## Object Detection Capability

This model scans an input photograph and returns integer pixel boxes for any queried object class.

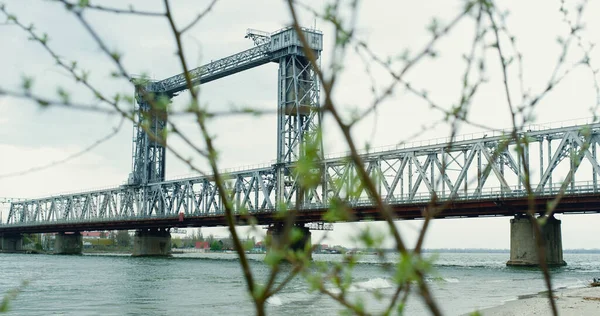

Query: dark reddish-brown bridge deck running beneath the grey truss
[0,193,600,234]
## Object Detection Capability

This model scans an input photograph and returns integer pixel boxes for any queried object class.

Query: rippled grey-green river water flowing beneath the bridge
[0,253,600,316]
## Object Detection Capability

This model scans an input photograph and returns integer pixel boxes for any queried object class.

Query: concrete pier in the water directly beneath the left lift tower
[132,228,171,257]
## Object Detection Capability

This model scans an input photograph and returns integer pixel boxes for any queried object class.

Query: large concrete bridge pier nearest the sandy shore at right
[506,216,567,267]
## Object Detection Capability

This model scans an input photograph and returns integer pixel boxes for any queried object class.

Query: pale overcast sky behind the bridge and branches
[0,0,600,248]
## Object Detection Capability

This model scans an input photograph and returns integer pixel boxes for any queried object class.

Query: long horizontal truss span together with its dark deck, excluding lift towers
[0,124,600,231]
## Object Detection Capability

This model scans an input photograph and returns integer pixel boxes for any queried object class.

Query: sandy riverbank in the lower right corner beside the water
[480,287,600,316]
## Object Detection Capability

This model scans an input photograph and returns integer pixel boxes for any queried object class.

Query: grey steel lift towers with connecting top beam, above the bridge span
[128,27,323,213]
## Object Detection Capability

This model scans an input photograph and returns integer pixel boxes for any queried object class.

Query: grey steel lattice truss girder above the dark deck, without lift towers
[7,124,600,225]
